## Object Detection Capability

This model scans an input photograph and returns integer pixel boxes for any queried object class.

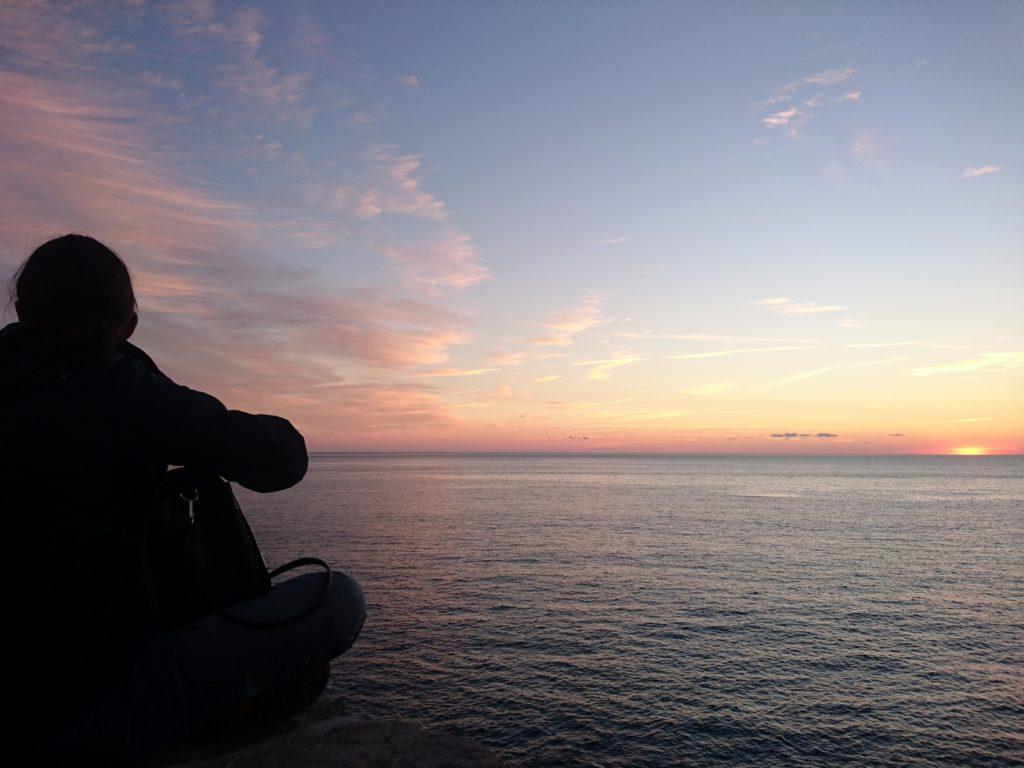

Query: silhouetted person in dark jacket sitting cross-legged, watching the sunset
[0,234,365,765]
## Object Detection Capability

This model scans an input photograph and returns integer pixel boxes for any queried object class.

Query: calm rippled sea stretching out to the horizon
[239,455,1024,766]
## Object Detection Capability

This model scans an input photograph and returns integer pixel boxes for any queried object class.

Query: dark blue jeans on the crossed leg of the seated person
[60,571,366,762]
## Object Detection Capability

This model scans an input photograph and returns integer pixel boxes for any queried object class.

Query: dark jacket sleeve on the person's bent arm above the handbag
[103,353,308,493]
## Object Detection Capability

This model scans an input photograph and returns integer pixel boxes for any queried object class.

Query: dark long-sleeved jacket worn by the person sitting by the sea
[0,323,307,741]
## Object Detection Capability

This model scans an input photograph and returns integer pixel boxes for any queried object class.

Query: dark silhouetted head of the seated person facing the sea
[11,234,138,365]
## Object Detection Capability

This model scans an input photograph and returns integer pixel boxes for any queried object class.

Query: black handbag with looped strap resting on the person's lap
[142,467,331,630]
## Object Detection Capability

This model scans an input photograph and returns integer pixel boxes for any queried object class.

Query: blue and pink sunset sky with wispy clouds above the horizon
[0,0,1024,455]
